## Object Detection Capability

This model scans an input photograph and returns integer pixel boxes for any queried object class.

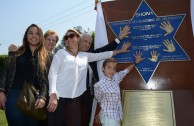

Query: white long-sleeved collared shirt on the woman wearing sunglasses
[48,49,113,98]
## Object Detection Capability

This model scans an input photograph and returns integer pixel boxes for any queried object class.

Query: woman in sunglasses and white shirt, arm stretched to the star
[48,29,129,126]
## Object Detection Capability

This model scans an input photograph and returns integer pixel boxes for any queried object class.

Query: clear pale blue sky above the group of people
[0,0,112,55]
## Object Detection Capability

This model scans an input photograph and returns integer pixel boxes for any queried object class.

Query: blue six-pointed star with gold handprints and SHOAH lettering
[108,0,190,83]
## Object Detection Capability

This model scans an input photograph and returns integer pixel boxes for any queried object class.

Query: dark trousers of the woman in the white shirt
[48,96,81,126]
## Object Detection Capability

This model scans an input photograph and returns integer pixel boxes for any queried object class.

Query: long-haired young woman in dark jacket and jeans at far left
[0,24,50,126]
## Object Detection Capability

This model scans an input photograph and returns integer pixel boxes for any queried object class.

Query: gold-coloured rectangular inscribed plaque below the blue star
[122,90,176,126]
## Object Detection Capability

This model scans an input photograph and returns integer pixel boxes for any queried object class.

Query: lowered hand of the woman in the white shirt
[47,93,58,112]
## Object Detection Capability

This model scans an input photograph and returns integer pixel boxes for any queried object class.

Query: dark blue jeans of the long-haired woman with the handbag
[5,89,38,126]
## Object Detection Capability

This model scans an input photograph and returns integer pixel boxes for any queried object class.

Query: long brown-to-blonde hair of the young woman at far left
[16,24,49,74]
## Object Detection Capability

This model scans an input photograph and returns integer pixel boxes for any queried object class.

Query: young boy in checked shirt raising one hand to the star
[94,52,144,126]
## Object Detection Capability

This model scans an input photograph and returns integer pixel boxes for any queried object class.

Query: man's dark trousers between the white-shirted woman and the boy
[81,88,93,126]
